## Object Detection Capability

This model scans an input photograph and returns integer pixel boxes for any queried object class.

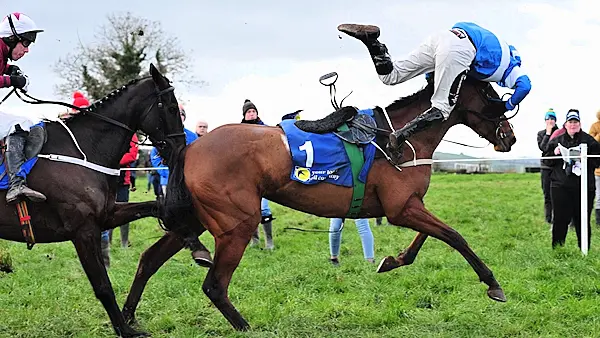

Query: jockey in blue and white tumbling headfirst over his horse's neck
[338,22,531,163]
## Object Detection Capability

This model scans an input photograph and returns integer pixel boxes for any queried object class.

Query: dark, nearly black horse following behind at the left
[0,65,185,337]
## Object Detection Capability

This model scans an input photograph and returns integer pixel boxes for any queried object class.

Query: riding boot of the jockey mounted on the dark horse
[6,131,46,204]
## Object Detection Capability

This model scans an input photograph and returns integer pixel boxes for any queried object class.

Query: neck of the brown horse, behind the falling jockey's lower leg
[388,101,456,159]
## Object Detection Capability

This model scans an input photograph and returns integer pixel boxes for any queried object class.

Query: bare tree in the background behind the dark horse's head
[54,12,204,99]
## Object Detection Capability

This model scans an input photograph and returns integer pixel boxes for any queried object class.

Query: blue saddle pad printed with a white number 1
[279,110,375,187]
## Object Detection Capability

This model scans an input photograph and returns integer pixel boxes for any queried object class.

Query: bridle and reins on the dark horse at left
[11,84,185,149]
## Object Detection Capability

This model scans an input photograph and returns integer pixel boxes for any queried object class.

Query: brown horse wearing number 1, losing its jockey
[123,76,516,330]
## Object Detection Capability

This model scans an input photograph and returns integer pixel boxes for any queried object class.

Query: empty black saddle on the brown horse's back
[295,107,377,145]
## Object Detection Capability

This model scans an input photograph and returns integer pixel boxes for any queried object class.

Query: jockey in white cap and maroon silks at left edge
[0,13,46,203]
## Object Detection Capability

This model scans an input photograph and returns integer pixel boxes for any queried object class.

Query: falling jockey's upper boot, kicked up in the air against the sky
[338,24,394,75]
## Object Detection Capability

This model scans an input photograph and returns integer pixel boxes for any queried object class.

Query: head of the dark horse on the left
[138,64,185,164]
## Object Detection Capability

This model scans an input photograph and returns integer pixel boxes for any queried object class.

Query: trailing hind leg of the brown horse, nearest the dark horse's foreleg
[123,232,185,324]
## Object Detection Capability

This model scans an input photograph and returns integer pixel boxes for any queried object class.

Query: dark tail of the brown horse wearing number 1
[163,147,193,230]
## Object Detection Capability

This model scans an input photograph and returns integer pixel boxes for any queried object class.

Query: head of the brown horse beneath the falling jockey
[454,78,517,152]
